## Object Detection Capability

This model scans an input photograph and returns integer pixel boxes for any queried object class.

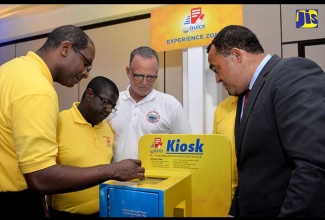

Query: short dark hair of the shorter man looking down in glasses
[82,76,119,99]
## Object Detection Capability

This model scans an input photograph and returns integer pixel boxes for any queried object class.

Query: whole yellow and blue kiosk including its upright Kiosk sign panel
[99,134,232,217]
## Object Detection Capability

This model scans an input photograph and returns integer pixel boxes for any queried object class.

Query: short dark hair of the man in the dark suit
[207,25,264,56]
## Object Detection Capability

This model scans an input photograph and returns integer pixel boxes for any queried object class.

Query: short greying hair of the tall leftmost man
[39,25,94,51]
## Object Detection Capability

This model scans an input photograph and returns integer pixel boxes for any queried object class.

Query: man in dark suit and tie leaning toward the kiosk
[207,25,325,217]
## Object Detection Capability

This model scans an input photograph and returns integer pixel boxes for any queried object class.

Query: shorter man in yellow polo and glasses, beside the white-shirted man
[50,76,119,219]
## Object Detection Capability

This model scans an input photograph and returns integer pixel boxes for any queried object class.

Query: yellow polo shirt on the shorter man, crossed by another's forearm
[52,102,114,214]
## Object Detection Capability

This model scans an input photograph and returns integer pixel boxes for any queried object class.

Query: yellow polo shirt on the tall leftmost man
[0,51,59,191]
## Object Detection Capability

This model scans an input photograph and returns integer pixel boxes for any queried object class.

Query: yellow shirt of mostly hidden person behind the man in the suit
[213,96,238,196]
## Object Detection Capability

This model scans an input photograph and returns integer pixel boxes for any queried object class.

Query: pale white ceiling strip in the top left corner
[0,4,165,43]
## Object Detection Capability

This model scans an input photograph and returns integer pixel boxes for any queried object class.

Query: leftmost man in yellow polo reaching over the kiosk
[0,25,144,219]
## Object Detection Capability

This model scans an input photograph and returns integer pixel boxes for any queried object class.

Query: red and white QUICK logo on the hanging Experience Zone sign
[183,7,205,33]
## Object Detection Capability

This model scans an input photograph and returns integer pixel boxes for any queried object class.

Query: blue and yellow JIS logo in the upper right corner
[296,9,318,28]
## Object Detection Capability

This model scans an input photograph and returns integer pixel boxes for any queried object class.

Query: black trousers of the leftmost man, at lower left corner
[0,189,46,219]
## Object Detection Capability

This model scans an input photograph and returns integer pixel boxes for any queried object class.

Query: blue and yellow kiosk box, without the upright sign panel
[100,171,192,217]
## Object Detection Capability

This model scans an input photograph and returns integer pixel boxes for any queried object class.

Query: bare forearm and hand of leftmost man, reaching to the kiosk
[24,159,145,194]
